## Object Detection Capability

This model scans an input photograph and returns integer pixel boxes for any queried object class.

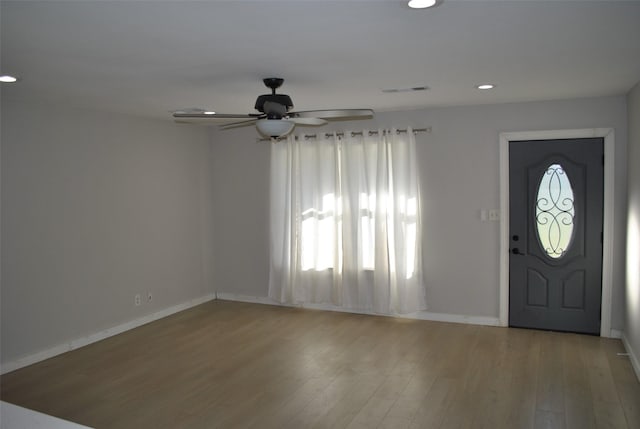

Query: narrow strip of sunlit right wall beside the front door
[624,82,640,368]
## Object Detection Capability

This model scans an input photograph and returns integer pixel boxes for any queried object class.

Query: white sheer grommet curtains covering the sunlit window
[269,125,426,314]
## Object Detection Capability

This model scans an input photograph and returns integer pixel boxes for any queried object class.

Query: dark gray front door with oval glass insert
[509,138,604,334]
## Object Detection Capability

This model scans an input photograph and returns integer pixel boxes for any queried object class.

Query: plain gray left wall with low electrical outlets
[1,100,213,363]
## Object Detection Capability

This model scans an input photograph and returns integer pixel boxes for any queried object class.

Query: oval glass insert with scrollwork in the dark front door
[536,164,575,259]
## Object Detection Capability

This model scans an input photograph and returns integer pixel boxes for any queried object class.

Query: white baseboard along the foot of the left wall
[0,294,216,374]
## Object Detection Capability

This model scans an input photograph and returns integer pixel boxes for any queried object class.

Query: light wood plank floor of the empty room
[0,301,640,429]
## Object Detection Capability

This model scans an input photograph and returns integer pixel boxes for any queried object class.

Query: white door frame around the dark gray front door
[500,128,615,337]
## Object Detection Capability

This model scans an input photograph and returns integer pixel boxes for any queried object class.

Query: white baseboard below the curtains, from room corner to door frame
[217,292,500,326]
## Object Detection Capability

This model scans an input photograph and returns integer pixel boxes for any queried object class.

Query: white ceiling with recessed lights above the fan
[0,0,640,120]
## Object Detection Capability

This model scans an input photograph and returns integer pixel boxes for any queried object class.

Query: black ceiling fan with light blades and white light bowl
[173,77,373,138]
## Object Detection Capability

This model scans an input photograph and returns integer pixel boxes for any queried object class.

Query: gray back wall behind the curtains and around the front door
[212,97,627,329]
